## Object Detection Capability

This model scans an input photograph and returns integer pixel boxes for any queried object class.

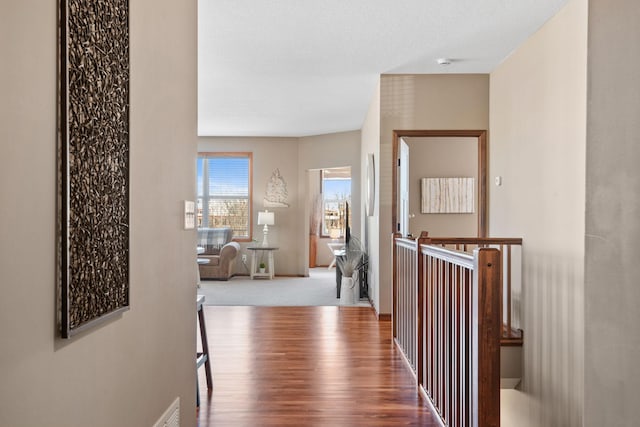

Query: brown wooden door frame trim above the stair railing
[391,130,488,237]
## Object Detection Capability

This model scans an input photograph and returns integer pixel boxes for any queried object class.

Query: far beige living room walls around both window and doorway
[197,131,360,275]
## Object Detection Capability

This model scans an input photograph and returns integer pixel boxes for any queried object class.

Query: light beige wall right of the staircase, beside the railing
[489,0,588,427]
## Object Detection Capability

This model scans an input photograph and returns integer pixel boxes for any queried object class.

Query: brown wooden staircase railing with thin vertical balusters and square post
[392,233,522,426]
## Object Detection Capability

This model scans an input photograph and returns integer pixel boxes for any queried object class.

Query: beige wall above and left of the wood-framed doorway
[376,74,489,313]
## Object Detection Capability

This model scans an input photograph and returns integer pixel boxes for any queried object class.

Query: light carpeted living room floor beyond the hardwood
[198,267,369,306]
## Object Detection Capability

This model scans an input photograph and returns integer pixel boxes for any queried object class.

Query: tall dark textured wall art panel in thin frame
[59,0,129,338]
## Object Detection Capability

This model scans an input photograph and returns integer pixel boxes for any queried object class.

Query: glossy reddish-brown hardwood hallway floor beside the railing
[198,306,440,427]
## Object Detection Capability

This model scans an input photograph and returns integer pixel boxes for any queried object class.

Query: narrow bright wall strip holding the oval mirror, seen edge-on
[360,80,380,313]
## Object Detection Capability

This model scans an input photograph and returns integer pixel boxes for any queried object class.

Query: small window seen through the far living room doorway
[320,167,351,237]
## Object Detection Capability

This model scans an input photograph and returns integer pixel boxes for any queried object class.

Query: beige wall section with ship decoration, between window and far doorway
[194,137,306,276]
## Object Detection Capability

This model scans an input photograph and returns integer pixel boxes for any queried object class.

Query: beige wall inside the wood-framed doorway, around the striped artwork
[404,137,478,237]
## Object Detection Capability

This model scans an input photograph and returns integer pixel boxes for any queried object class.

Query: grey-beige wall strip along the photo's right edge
[584,0,640,427]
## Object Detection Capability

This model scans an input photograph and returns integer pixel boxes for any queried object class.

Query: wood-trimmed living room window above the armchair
[196,153,252,240]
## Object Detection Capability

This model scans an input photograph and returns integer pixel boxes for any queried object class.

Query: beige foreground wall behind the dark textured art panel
[0,0,196,427]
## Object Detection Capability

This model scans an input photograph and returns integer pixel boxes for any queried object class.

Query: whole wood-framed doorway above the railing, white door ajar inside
[391,130,487,237]
